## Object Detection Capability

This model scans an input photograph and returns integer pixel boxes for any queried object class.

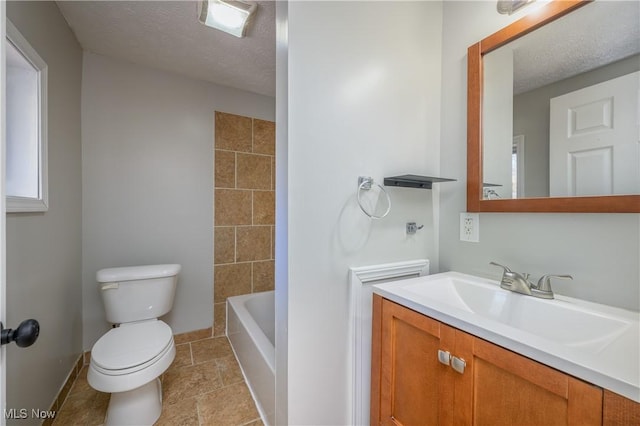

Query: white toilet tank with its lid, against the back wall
[96,264,181,324]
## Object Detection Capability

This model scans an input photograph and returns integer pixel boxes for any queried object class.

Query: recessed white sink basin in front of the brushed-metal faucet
[404,274,631,349]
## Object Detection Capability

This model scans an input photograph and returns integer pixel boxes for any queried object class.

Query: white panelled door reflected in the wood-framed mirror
[549,72,640,197]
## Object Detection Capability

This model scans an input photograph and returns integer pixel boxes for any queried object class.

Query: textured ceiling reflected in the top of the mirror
[508,0,640,93]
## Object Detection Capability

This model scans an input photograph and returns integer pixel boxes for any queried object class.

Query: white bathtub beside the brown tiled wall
[227,291,276,426]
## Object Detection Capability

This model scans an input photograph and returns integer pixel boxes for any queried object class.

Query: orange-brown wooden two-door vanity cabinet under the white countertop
[371,295,603,426]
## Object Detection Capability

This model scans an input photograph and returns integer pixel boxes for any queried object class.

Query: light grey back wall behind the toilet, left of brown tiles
[82,52,275,350]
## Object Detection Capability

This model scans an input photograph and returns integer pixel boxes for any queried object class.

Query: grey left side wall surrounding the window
[6,2,82,423]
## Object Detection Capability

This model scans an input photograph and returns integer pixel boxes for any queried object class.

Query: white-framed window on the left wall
[6,20,48,213]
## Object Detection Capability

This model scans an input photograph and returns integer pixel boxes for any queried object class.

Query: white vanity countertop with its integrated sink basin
[373,272,640,402]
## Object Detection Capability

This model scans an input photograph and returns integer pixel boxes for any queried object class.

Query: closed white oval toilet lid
[91,320,173,370]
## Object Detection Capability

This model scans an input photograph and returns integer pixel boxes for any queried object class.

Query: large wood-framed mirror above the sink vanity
[467,0,640,213]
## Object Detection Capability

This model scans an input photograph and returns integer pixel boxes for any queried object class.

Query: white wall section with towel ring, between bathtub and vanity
[276,2,442,425]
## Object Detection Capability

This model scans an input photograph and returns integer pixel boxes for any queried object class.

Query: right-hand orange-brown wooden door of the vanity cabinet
[454,330,602,426]
